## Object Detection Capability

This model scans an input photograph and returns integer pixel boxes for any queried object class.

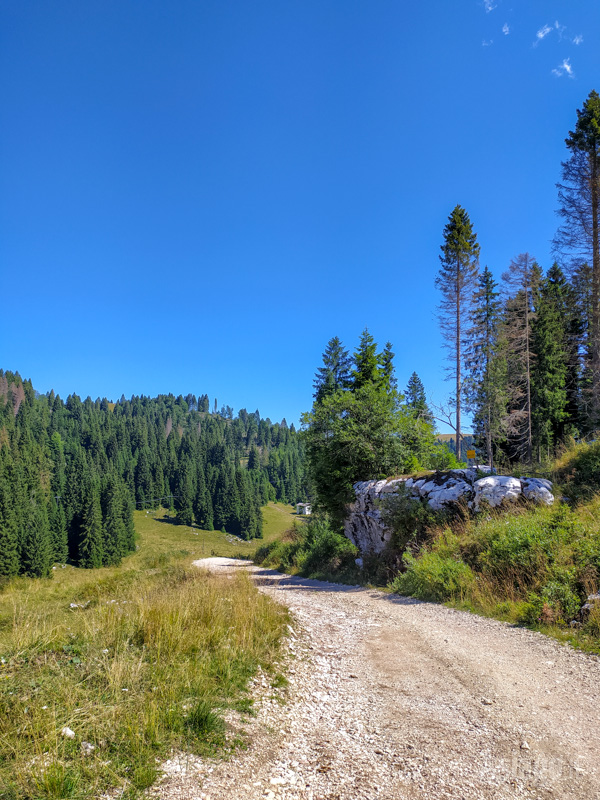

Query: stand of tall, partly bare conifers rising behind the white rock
[436,91,600,464]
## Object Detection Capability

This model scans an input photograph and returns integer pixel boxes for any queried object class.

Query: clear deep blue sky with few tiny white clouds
[0,0,600,422]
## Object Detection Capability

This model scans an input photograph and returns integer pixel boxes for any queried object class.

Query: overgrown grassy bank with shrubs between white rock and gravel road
[388,443,600,652]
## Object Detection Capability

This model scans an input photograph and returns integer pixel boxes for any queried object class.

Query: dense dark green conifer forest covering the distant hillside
[0,370,307,576]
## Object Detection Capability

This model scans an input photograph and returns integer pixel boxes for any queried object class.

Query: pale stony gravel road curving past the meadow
[156,558,600,800]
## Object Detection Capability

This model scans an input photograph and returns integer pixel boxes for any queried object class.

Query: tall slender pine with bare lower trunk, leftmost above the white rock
[436,205,479,461]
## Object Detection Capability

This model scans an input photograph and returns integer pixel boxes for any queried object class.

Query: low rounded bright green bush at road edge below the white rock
[389,551,475,602]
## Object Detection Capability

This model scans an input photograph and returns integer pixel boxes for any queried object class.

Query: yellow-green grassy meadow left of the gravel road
[0,504,293,800]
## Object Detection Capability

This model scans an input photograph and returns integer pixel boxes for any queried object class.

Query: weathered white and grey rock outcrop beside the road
[344,467,554,554]
